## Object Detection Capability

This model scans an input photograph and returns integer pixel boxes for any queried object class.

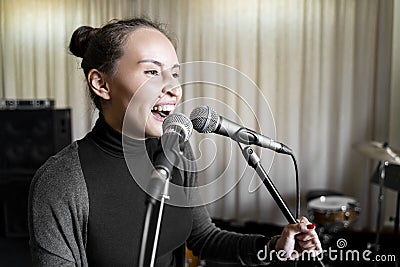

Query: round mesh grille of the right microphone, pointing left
[190,106,219,133]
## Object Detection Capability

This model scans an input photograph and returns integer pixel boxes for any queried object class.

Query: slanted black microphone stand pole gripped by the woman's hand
[237,142,325,267]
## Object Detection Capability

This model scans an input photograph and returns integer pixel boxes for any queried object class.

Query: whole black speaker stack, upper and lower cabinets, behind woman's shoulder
[0,109,71,236]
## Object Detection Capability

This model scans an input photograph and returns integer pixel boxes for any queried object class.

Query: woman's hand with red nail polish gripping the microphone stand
[271,217,322,259]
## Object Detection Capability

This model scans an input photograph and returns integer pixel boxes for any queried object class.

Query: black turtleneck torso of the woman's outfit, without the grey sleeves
[78,117,192,267]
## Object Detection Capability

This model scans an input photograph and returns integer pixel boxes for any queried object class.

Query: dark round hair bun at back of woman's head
[69,26,97,58]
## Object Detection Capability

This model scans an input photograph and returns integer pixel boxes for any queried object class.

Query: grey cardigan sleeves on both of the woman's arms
[28,142,268,267]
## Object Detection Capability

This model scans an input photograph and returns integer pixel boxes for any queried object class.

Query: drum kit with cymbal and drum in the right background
[307,141,400,248]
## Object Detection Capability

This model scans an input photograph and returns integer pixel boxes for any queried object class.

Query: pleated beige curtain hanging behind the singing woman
[0,0,400,228]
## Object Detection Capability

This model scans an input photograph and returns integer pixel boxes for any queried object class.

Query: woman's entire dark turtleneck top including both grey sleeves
[28,117,268,267]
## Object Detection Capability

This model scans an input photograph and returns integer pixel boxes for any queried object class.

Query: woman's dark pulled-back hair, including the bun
[69,18,176,111]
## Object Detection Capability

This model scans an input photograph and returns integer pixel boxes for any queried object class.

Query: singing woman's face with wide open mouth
[103,28,182,138]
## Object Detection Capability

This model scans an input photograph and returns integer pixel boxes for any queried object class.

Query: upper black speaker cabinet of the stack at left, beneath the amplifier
[0,109,71,174]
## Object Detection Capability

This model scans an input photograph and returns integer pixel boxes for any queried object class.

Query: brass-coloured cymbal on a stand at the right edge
[354,141,400,165]
